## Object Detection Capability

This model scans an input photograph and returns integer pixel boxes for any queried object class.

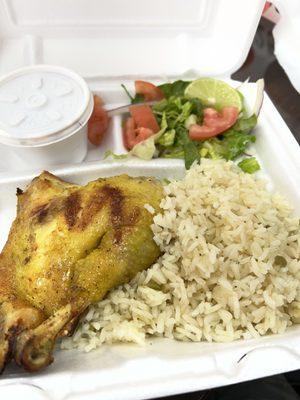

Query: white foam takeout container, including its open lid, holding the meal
[0,0,300,400]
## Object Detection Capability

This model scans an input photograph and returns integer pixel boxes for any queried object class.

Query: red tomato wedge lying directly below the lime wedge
[189,107,239,141]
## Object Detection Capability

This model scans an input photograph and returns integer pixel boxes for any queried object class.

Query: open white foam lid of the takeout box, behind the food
[0,0,264,79]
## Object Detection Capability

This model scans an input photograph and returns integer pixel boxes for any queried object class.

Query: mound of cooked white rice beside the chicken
[62,160,300,351]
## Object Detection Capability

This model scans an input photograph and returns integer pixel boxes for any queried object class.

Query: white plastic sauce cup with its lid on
[0,65,93,170]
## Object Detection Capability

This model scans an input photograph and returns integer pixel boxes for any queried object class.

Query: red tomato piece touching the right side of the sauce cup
[88,95,109,146]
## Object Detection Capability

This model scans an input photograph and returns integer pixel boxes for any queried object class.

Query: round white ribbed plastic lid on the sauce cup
[0,65,91,145]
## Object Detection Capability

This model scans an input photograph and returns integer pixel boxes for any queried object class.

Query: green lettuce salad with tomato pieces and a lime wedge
[118,78,260,173]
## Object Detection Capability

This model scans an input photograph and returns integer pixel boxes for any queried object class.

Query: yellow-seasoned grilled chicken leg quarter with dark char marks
[0,172,163,371]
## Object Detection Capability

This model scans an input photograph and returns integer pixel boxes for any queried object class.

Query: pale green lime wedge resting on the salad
[184,78,243,111]
